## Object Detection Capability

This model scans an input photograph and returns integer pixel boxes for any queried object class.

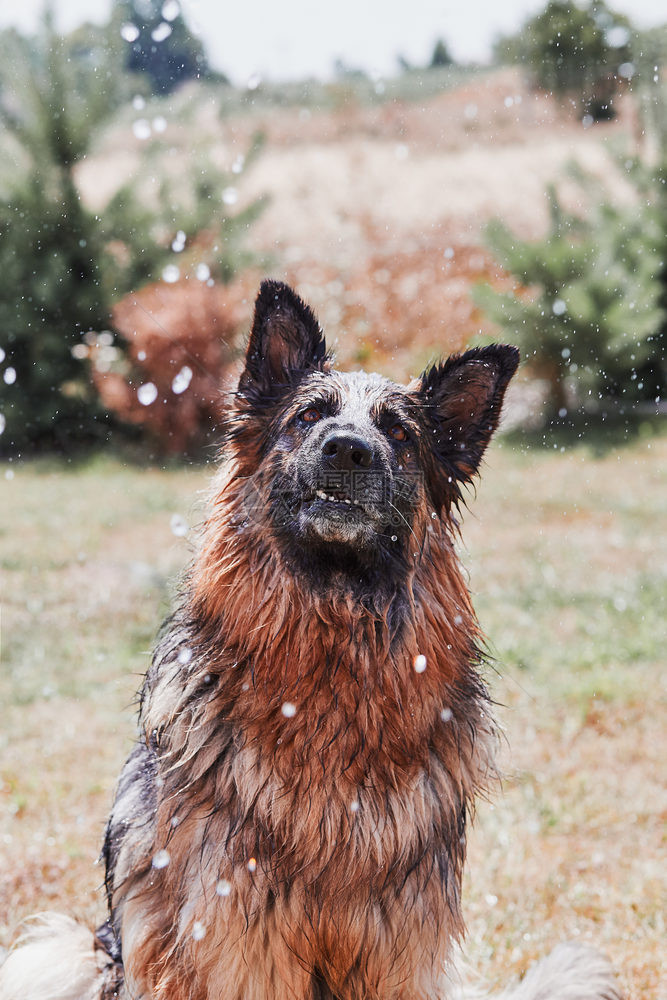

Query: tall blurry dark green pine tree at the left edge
[0,20,116,451]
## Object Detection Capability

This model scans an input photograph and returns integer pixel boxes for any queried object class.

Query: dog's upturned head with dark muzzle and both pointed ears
[222,281,519,579]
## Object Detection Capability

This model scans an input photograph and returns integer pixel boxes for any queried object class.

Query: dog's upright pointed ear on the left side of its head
[239,281,327,396]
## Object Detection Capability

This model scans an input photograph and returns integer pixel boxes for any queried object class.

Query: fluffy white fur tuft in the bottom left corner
[0,913,104,1000]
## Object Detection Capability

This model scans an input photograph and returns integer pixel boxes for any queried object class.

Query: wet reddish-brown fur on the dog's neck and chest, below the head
[115,466,492,1000]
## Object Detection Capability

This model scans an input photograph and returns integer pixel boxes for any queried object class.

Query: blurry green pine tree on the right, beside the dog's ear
[477,178,665,418]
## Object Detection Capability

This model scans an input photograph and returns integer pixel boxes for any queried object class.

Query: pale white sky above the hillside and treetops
[0,0,667,84]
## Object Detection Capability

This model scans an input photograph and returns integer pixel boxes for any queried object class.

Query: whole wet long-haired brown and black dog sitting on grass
[0,281,619,1000]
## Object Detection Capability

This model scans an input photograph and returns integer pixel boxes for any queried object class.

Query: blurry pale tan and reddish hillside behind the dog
[79,69,638,376]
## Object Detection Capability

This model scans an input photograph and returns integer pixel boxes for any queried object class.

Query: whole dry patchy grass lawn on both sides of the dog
[0,437,667,1000]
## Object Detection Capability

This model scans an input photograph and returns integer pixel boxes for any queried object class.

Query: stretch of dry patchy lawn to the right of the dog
[465,439,667,1000]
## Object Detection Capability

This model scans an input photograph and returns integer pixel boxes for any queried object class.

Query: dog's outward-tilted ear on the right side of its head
[417,344,519,493]
